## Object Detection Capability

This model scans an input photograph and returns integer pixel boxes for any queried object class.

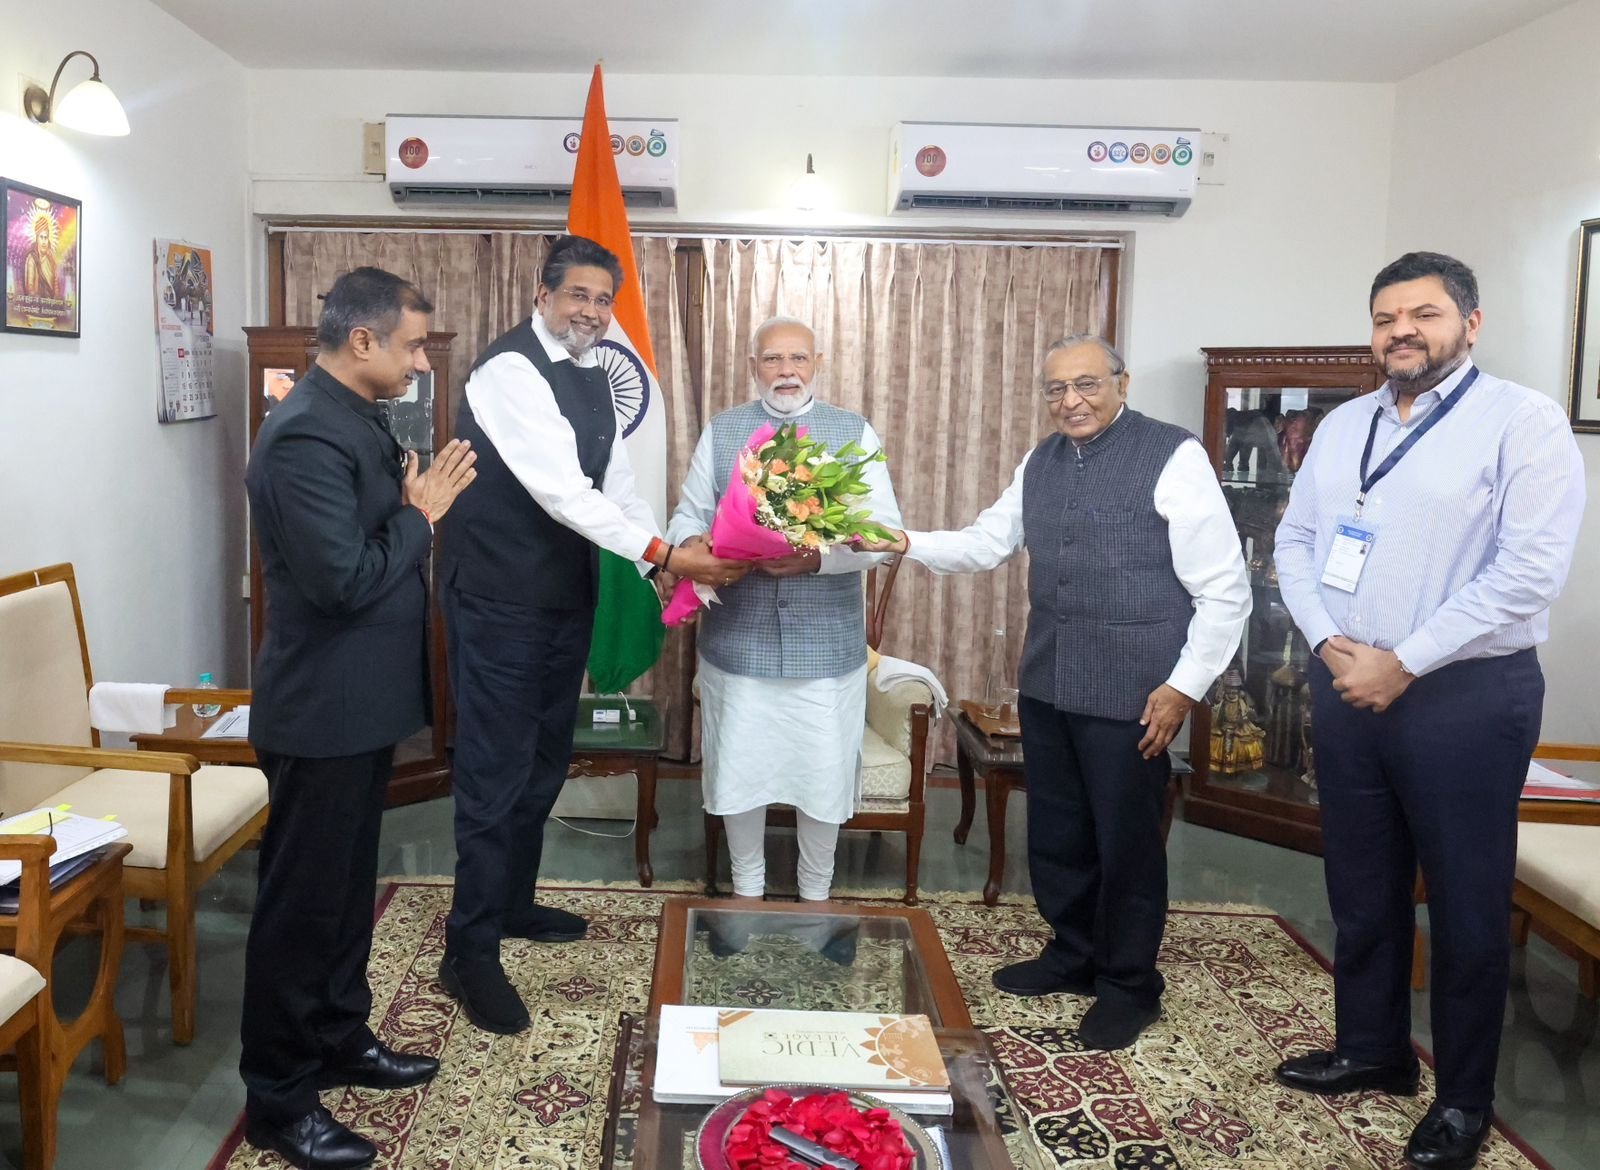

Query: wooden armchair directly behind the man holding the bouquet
[696,557,933,904]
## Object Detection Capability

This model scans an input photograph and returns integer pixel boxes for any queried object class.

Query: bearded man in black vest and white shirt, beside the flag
[438,235,747,1034]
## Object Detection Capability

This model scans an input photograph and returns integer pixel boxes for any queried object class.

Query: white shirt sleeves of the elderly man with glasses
[906,413,1250,703]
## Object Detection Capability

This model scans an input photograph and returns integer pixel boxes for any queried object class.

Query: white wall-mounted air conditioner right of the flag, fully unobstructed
[890,122,1200,216]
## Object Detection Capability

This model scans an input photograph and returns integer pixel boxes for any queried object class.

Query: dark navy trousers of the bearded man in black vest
[443,586,594,960]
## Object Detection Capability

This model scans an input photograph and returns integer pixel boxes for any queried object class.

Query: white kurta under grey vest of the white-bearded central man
[667,403,901,824]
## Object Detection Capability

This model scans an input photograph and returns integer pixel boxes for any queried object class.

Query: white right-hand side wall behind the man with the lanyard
[1387,0,1600,743]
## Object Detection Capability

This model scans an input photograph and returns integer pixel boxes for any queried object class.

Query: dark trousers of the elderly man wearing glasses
[1018,696,1171,1007]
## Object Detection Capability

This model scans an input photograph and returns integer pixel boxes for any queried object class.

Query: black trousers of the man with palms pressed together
[238,747,394,1124]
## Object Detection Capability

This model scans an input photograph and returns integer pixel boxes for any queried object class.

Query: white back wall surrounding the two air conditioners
[250,70,1394,438]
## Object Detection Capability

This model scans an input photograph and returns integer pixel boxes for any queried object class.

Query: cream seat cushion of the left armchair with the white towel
[48,765,267,869]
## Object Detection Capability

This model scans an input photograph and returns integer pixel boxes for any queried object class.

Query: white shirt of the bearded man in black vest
[466,314,661,573]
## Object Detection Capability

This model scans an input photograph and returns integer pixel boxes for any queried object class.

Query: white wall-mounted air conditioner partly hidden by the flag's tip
[384,114,678,208]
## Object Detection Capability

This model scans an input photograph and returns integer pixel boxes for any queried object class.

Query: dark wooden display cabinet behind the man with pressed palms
[245,325,456,807]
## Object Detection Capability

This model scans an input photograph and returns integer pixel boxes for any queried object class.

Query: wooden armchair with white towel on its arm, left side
[0,565,267,1044]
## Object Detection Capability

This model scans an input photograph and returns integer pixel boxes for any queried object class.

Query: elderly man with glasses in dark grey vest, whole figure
[874,335,1250,1050]
